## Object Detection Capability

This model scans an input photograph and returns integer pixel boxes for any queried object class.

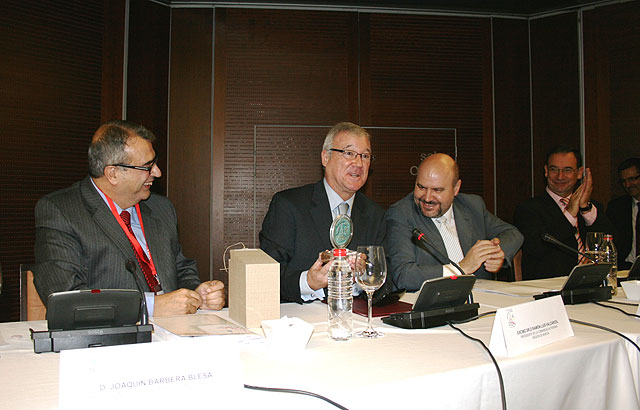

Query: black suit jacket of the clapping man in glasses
[513,192,613,280]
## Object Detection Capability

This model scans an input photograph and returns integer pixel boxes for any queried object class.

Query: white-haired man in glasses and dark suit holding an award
[260,122,385,303]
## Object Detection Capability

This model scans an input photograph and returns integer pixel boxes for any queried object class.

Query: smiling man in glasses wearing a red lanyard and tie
[33,120,224,316]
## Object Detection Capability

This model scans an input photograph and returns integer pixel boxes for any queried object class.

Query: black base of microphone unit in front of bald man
[382,303,480,329]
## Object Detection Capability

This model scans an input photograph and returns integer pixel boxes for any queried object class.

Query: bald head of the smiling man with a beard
[413,154,461,218]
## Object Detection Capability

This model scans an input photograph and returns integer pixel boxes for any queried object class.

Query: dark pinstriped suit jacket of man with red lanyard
[33,177,200,304]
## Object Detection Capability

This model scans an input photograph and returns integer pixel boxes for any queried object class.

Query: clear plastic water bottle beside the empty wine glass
[327,249,353,340]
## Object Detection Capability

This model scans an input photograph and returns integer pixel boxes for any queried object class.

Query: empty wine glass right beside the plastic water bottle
[355,246,387,338]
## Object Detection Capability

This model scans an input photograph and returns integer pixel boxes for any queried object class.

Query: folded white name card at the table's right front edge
[489,296,573,357]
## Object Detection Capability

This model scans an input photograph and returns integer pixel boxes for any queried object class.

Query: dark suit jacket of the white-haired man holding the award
[260,180,385,303]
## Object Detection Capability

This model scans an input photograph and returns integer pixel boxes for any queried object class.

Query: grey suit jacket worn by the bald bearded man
[385,192,522,291]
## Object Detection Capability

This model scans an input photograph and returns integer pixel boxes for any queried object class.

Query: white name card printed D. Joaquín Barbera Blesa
[59,336,243,410]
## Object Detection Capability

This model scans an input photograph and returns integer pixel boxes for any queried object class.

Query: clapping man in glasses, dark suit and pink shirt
[514,146,613,280]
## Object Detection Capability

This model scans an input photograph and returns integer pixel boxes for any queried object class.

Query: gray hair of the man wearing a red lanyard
[89,120,156,178]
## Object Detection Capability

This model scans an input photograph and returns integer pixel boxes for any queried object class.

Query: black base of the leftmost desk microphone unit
[30,325,153,353]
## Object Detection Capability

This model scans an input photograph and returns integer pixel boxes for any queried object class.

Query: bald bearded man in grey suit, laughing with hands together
[386,154,522,291]
